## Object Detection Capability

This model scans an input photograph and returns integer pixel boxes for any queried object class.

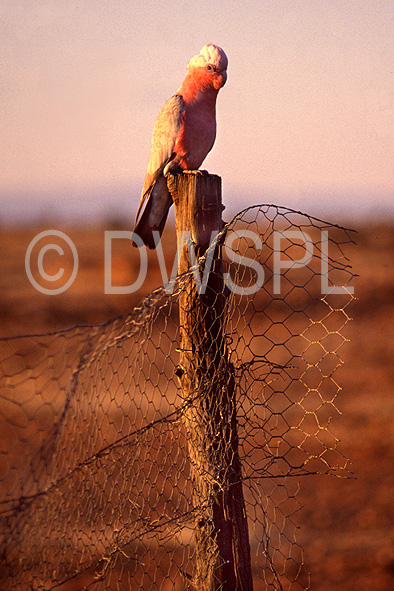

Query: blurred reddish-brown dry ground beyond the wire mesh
[0,220,394,591]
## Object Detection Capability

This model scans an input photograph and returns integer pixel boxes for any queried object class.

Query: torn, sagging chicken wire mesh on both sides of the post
[0,205,353,591]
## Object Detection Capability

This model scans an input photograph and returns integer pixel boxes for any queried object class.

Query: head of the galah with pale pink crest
[187,43,228,90]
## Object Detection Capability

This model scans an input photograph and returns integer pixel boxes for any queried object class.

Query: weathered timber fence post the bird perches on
[167,171,253,591]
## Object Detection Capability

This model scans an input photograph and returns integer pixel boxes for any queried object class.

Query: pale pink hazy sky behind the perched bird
[0,0,394,225]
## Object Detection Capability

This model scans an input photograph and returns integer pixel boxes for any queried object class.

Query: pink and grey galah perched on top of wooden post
[134,44,228,248]
